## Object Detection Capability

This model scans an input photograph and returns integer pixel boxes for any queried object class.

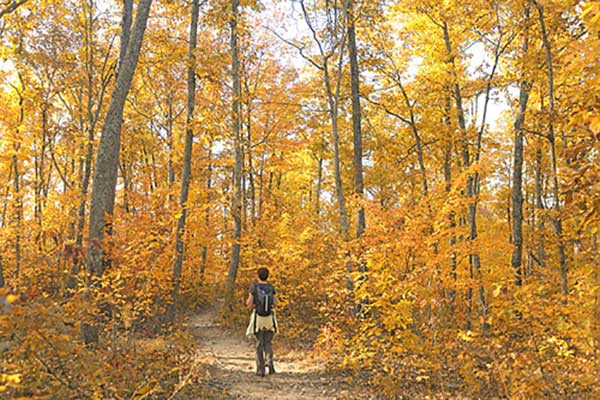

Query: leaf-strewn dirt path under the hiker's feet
[189,309,359,400]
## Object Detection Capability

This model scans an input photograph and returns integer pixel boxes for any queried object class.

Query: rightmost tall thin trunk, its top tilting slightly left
[535,1,569,296]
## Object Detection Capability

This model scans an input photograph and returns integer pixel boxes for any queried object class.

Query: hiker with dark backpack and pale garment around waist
[246,267,277,376]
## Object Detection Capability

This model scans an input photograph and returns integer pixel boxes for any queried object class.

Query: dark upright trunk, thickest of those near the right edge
[511,8,531,286]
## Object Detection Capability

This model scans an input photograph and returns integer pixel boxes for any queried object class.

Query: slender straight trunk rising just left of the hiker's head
[226,0,243,307]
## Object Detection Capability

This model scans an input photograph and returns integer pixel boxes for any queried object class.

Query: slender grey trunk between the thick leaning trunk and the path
[167,0,200,323]
